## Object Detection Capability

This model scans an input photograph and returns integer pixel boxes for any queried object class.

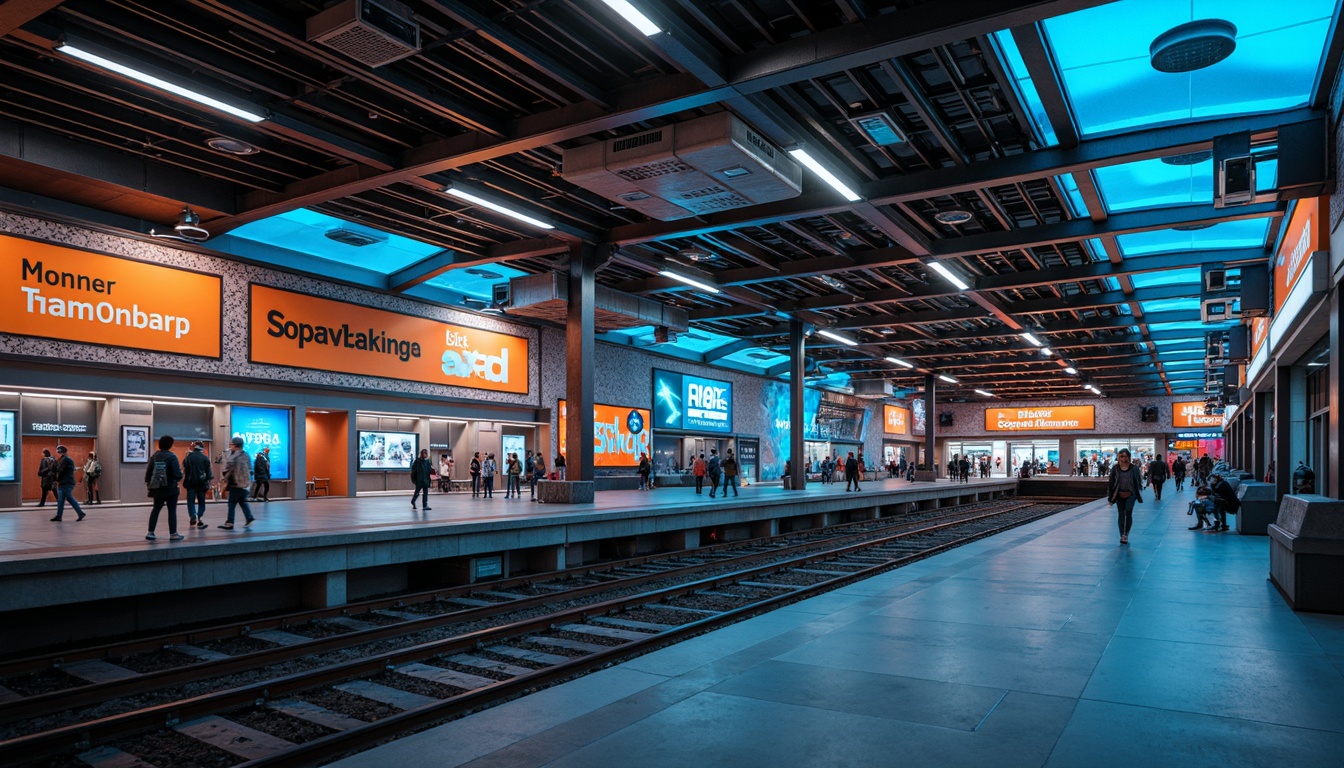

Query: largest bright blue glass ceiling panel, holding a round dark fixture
[1044,0,1335,135]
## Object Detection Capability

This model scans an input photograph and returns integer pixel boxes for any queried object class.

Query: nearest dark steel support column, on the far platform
[564,243,596,482]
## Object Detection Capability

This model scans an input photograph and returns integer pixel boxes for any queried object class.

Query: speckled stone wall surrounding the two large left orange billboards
[0,213,540,406]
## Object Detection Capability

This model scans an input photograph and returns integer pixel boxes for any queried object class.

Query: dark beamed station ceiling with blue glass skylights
[0,0,1340,398]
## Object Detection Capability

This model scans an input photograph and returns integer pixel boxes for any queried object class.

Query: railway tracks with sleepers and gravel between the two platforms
[0,499,1078,768]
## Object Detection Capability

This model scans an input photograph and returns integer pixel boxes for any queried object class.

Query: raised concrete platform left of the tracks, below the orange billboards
[0,479,1017,650]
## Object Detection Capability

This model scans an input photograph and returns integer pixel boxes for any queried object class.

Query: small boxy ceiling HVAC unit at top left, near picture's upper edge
[308,0,419,67]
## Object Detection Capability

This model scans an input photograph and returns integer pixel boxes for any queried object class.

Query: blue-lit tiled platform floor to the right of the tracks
[335,490,1344,768]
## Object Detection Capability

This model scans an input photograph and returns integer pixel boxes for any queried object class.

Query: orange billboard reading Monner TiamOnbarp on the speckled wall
[0,235,223,358]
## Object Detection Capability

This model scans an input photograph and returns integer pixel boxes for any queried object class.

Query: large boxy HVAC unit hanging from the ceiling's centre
[562,112,802,221]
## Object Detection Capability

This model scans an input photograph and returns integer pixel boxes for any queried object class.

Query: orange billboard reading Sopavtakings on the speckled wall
[250,284,528,394]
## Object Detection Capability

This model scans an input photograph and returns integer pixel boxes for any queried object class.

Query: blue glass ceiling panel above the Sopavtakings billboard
[228,208,444,274]
